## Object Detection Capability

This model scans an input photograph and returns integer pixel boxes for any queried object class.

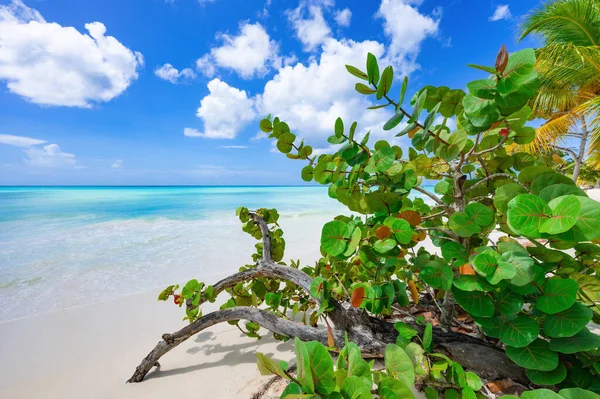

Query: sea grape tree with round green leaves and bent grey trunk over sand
[131,46,600,391]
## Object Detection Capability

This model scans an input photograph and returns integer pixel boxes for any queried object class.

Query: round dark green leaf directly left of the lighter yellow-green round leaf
[507,194,552,238]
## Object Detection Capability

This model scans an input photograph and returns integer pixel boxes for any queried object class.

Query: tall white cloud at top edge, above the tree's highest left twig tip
[377,0,442,75]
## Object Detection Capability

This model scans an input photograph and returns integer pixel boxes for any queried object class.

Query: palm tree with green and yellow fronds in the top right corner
[521,0,600,181]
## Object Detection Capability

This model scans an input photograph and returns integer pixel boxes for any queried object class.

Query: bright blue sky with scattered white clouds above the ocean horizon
[0,0,540,185]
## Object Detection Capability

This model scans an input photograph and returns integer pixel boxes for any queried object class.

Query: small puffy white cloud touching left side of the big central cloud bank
[188,79,257,139]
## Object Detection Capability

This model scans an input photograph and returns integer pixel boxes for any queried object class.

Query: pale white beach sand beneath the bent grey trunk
[0,190,600,399]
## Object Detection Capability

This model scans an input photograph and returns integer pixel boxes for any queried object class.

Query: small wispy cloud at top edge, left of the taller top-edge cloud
[287,0,333,51]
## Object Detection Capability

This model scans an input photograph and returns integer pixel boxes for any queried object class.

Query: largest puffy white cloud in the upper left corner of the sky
[0,0,143,107]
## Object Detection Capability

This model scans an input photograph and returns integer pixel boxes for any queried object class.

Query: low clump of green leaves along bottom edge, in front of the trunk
[256,330,496,399]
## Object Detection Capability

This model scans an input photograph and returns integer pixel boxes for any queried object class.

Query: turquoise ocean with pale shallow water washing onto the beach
[0,187,432,322]
